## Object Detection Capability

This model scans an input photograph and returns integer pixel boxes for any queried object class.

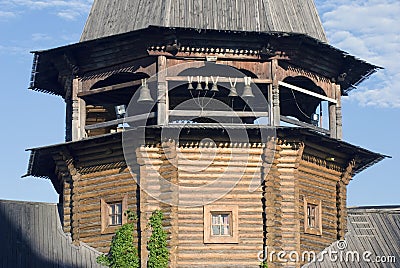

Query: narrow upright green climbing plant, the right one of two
[147,210,169,268]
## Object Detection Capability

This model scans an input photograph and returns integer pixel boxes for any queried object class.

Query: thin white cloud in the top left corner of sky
[0,0,93,20]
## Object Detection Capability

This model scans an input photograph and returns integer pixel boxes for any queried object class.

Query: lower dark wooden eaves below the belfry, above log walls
[25,127,386,190]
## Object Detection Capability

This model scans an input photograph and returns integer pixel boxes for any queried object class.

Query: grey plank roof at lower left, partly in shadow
[0,200,102,268]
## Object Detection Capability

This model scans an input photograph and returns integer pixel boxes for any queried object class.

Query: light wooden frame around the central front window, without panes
[203,205,239,244]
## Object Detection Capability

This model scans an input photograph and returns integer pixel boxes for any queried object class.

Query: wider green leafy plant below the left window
[96,210,140,268]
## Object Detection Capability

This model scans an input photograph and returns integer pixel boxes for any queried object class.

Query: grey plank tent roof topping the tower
[81,0,327,42]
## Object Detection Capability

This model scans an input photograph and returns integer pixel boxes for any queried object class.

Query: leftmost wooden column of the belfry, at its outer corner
[71,78,86,141]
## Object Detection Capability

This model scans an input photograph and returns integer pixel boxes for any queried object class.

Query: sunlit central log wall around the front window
[177,143,263,267]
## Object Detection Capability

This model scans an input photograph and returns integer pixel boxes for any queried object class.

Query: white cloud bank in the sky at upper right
[317,0,400,108]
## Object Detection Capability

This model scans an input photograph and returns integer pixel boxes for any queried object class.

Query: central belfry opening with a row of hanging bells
[168,63,268,124]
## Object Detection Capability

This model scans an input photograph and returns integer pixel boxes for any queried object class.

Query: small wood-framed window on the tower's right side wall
[304,197,322,235]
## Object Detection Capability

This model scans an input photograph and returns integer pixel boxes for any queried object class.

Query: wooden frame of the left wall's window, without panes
[100,196,128,234]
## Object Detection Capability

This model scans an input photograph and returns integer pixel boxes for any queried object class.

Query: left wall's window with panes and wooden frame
[101,196,128,234]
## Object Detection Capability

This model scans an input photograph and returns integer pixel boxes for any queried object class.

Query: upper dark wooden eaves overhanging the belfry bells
[30,26,379,96]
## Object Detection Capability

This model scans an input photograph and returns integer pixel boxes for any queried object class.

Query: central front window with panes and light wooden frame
[204,205,239,244]
